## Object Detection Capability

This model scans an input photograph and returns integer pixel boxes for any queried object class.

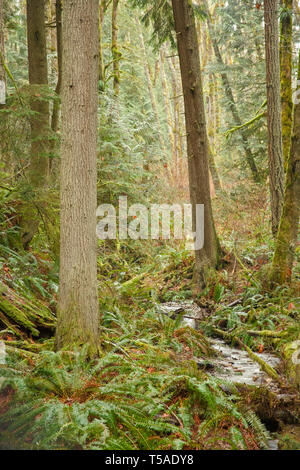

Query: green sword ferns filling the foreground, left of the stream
[0,332,269,450]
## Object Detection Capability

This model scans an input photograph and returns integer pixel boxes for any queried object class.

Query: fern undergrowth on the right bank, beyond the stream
[200,287,300,352]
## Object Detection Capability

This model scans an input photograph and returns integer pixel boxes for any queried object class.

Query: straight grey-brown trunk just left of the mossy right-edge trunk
[264,0,284,236]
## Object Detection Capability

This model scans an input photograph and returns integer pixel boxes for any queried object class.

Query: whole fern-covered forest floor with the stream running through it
[0,182,300,450]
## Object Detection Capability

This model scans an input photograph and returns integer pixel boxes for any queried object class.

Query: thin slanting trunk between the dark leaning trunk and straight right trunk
[203,0,260,182]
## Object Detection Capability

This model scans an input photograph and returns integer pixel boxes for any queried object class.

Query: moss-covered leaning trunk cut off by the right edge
[271,48,300,284]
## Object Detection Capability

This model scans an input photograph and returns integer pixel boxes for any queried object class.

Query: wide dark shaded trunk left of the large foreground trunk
[21,0,50,247]
